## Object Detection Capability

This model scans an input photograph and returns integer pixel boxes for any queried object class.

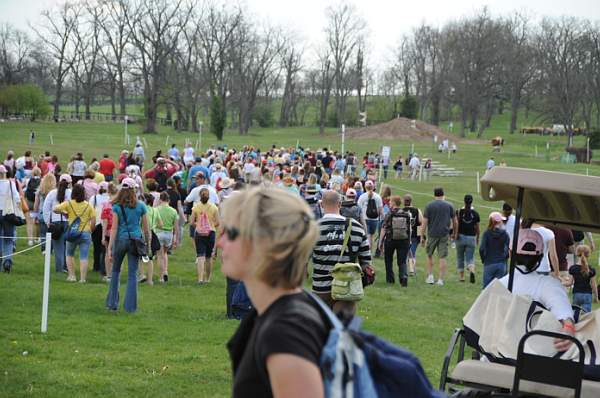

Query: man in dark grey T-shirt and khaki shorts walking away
[421,188,458,286]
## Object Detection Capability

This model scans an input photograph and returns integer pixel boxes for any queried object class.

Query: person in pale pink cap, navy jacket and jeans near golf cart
[479,211,509,289]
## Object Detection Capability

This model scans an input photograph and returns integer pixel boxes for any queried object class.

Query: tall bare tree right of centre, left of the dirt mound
[325,3,366,124]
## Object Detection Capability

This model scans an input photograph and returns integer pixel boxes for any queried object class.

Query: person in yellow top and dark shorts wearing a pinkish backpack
[190,188,219,285]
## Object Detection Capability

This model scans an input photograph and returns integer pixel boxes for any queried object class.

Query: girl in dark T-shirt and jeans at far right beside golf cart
[569,245,598,312]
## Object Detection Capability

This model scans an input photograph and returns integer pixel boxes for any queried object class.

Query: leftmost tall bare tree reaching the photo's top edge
[32,2,80,120]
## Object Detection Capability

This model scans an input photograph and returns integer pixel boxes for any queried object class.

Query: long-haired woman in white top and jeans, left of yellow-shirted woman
[43,174,71,272]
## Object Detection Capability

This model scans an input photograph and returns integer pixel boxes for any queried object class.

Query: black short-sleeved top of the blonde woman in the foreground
[227,292,331,397]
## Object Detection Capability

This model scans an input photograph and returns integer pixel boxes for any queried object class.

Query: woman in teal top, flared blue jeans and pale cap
[106,178,150,312]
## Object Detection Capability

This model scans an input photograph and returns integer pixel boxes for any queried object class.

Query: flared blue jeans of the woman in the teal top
[106,239,139,312]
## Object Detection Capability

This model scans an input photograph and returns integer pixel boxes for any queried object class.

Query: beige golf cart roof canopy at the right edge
[480,167,600,232]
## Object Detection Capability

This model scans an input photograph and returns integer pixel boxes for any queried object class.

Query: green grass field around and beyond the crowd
[0,115,600,397]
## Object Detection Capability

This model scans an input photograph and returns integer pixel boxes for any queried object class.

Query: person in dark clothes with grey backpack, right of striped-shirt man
[380,196,413,287]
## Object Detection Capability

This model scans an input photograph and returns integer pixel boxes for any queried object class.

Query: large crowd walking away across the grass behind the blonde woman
[0,139,597,308]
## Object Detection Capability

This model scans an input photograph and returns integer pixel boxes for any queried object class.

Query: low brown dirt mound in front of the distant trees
[346,117,457,142]
